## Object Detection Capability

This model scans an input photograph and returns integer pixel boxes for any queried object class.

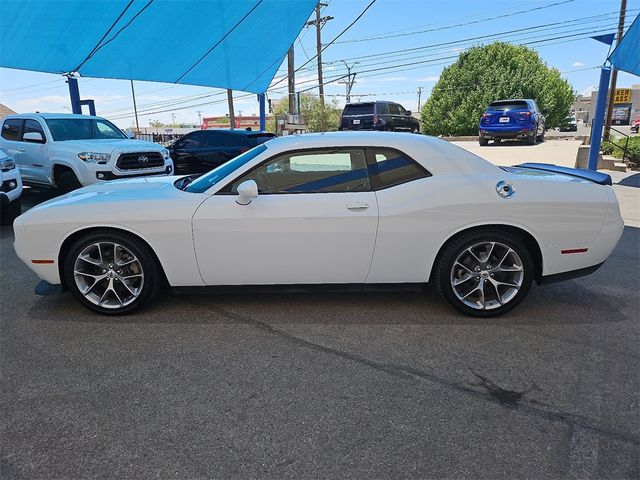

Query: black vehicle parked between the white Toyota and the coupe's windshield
[167,129,275,175]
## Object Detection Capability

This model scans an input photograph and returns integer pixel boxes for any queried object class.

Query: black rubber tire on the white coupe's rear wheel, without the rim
[431,228,535,318]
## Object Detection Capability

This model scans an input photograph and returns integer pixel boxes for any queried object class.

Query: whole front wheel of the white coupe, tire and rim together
[63,230,164,315]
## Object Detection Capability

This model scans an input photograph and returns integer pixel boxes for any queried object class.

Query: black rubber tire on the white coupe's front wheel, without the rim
[62,230,165,315]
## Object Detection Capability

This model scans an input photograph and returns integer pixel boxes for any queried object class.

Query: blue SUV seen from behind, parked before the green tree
[478,98,544,146]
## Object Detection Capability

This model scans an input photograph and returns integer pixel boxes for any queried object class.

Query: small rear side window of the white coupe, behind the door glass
[367,148,431,190]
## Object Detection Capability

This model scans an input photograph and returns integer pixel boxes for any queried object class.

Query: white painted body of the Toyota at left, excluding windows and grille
[0,113,173,187]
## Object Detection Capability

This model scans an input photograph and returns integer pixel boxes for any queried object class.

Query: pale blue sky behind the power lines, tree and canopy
[0,0,640,128]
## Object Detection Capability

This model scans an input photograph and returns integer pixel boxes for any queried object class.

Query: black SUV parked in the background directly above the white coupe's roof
[338,102,420,133]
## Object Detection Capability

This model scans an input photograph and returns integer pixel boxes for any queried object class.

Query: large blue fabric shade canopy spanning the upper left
[0,0,316,93]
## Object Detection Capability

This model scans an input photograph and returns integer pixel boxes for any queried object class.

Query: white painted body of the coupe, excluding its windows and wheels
[14,132,623,314]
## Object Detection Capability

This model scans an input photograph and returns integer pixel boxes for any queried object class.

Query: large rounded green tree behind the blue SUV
[421,42,575,135]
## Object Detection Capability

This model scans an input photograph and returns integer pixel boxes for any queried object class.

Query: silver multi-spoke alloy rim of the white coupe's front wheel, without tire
[73,242,144,309]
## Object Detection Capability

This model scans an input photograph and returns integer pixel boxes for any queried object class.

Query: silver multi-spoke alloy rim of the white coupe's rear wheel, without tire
[451,242,524,310]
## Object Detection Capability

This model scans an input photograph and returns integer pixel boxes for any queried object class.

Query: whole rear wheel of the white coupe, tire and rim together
[434,230,534,317]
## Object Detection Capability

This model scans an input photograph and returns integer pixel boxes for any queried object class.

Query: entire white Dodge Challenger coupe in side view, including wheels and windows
[14,132,623,317]
